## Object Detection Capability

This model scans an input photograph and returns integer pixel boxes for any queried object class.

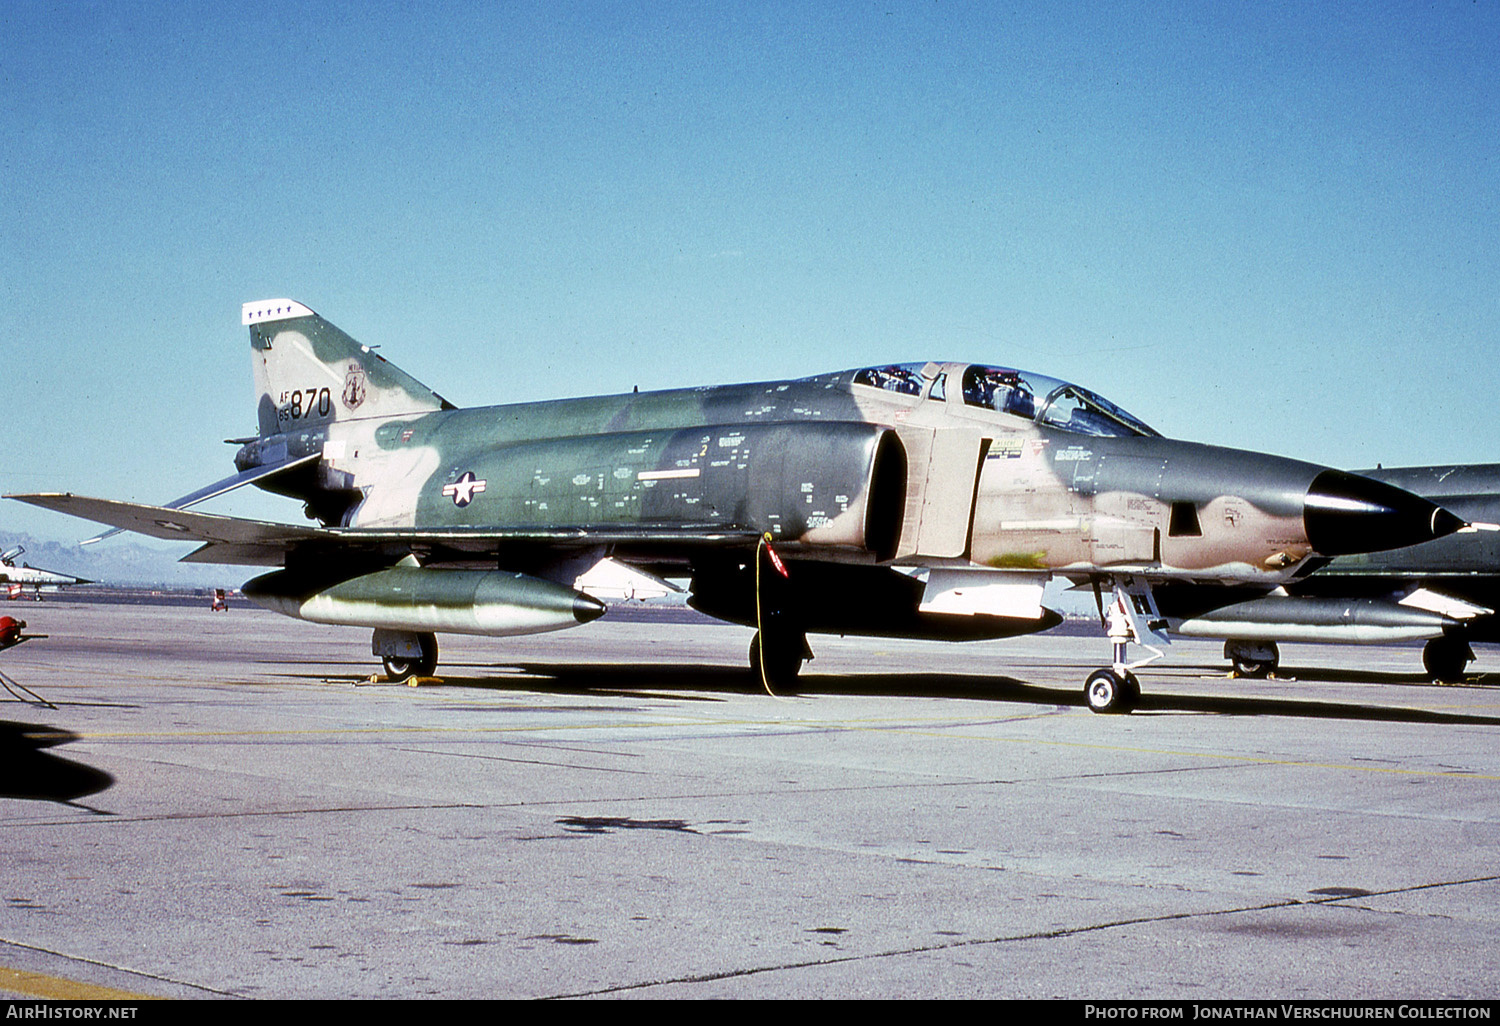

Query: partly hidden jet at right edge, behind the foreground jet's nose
[1157,464,1500,681]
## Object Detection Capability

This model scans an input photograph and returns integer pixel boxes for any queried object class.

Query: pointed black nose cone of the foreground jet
[1302,471,1464,557]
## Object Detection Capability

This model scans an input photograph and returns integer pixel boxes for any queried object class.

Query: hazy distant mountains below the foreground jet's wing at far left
[0,528,246,588]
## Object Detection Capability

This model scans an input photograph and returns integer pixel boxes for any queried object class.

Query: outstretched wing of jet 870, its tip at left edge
[6,492,759,567]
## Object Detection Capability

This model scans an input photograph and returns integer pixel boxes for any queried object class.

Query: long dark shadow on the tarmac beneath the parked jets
[405,663,1500,726]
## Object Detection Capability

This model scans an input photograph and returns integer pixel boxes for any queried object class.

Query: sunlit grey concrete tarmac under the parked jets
[0,603,1500,1001]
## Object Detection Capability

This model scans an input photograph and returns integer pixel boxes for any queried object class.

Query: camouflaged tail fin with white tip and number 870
[242,299,455,438]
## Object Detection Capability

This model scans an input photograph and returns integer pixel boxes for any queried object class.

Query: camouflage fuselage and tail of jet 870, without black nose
[237,303,1325,594]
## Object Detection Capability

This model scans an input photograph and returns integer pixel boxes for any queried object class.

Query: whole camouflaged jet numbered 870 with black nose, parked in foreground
[15,300,1463,713]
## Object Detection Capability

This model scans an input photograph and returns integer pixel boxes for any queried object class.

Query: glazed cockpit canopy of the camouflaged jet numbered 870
[854,363,1160,435]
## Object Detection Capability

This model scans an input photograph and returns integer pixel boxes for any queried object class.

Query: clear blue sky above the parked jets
[0,0,1500,540]
